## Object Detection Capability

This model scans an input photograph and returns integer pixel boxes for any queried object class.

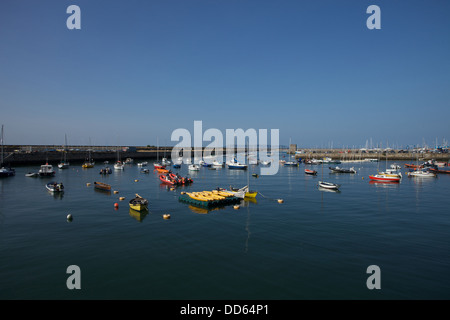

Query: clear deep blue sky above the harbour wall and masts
[0,0,450,147]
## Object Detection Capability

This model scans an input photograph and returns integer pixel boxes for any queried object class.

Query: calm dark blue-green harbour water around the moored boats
[0,161,450,300]
